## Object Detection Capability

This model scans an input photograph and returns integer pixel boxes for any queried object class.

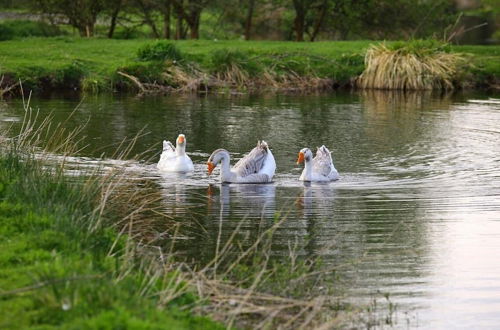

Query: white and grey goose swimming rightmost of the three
[297,146,339,181]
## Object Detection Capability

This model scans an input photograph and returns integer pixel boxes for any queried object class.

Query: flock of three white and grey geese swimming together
[157,134,339,183]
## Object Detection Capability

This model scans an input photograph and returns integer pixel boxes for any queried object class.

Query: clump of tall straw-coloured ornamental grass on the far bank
[357,40,465,90]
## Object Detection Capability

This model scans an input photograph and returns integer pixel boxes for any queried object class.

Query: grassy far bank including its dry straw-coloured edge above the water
[0,37,500,92]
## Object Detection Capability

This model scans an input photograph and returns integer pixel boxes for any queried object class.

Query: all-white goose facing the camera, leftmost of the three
[156,134,194,173]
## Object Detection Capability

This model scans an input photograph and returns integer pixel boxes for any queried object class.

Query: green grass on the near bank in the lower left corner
[0,148,223,329]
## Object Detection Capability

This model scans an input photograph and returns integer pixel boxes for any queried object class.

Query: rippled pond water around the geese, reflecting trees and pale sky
[0,92,500,329]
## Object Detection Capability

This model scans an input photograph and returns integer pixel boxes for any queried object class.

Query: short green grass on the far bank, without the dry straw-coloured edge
[0,37,500,91]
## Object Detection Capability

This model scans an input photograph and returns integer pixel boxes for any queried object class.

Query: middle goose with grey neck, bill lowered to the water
[207,141,276,183]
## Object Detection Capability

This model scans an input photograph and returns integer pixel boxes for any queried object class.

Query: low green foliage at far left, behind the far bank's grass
[0,20,64,40]
